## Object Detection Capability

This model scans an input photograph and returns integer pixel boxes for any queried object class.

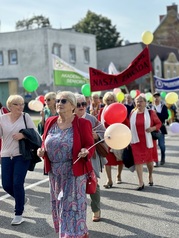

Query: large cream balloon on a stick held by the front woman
[104,123,132,150]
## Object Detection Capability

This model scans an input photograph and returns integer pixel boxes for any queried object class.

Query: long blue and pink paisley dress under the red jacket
[45,123,88,238]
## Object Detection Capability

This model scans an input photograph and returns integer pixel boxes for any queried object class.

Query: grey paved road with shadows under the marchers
[0,127,179,238]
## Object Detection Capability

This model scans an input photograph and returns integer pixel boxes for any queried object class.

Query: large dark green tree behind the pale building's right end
[72,10,123,50]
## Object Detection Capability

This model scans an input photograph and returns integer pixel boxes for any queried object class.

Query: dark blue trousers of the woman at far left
[1,155,30,215]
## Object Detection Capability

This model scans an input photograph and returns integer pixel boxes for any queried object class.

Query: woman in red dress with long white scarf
[130,95,162,191]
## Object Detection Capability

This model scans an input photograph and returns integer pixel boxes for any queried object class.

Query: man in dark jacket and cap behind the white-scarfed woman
[152,92,168,167]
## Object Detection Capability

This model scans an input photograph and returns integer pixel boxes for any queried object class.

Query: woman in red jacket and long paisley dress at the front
[38,91,95,238]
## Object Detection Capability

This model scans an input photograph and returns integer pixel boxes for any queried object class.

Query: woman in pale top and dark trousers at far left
[0,95,36,225]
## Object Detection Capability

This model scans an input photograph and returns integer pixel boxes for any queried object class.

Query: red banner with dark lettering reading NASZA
[89,47,151,92]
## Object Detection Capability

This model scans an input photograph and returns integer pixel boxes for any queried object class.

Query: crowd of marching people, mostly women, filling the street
[0,91,173,238]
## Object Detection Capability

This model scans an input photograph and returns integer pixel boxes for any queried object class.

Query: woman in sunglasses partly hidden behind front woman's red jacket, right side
[75,94,107,222]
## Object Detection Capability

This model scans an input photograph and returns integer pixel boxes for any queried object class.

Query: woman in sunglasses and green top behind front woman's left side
[37,92,58,135]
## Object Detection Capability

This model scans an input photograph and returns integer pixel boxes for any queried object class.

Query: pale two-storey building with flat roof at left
[0,28,97,104]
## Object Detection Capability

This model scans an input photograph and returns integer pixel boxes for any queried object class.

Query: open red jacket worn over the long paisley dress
[42,116,95,176]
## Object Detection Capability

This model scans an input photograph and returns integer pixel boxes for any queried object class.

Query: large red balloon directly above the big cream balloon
[104,102,127,125]
